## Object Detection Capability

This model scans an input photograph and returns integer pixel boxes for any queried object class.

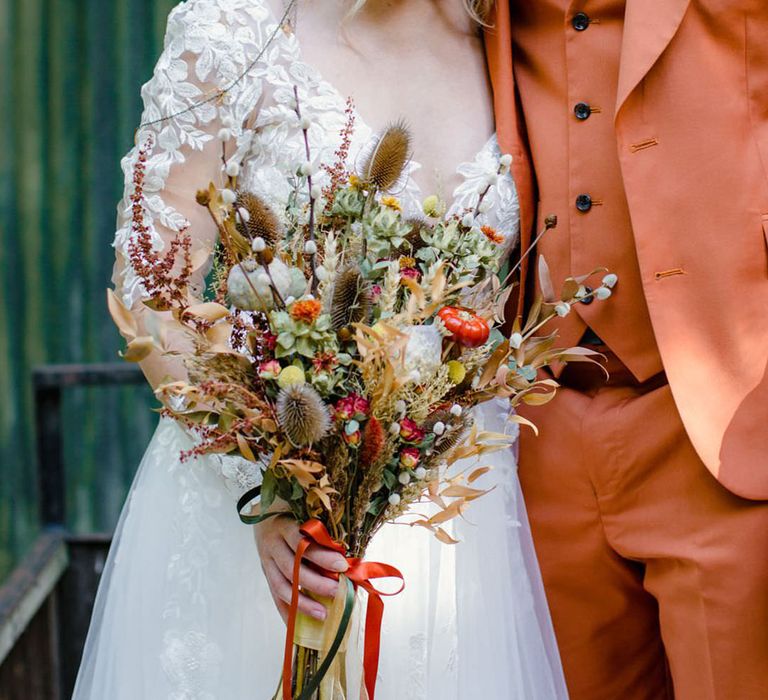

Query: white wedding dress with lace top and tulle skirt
[73,0,567,700]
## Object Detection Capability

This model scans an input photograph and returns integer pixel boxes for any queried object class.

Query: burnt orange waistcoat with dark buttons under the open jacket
[510,0,662,380]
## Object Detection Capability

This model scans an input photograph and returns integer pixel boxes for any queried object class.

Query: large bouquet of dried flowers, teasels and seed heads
[109,101,615,699]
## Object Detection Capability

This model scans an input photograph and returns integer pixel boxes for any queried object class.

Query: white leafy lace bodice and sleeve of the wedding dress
[113,0,519,504]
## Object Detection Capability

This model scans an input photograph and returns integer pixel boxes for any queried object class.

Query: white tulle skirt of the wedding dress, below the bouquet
[73,402,567,700]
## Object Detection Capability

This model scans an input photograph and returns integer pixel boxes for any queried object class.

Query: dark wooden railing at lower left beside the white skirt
[0,364,144,700]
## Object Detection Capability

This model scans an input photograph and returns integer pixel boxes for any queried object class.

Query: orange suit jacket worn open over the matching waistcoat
[485,0,768,499]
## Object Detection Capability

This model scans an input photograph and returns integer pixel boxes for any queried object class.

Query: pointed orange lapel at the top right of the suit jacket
[616,0,691,114]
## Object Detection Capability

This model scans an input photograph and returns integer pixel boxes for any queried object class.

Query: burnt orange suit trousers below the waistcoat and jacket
[520,359,768,700]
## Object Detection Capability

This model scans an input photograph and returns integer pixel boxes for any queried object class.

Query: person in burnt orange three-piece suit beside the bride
[486,0,768,700]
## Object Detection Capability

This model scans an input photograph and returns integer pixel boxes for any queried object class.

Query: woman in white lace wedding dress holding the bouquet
[73,0,566,700]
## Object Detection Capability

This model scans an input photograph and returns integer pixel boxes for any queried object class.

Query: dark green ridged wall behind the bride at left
[0,0,181,575]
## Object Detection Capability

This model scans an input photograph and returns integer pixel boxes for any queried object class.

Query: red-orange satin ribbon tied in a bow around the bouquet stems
[283,519,405,700]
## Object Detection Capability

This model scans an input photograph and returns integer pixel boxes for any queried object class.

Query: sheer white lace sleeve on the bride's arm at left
[112,0,292,385]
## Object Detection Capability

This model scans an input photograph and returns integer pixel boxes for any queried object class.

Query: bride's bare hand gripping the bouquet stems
[254,515,349,620]
